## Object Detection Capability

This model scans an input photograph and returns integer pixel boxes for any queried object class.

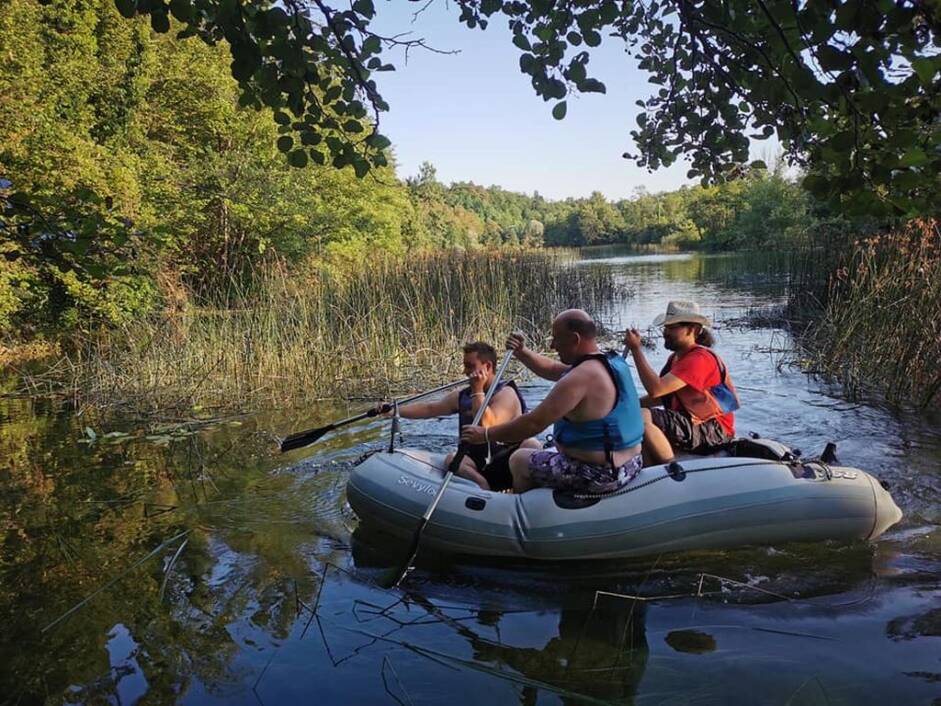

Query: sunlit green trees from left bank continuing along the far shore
[0,0,809,338]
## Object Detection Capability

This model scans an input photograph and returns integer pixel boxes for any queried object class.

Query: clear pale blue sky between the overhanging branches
[374,0,770,199]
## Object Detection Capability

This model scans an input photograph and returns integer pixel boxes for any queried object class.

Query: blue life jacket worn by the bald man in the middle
[552,351,644,453]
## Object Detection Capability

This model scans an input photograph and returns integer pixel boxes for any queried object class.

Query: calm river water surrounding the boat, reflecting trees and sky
[0,252,941,705]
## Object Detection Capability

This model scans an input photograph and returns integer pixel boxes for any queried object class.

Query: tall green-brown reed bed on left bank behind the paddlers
[69,251,626,411]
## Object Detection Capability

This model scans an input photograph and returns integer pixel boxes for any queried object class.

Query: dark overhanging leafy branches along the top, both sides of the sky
[106,0,941,215]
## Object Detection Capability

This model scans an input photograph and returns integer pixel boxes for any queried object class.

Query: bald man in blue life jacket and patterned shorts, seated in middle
[461,309,644,493]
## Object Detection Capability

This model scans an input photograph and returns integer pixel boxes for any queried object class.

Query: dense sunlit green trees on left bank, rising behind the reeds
[0,0,411,330]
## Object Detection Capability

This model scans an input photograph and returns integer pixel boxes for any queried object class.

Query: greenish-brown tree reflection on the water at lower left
[0,416,342,703]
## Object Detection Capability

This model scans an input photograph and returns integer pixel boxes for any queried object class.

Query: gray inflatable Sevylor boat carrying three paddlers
[347,439,902,561]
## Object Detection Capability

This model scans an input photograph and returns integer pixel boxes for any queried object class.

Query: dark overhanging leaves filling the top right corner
[618,0,941,216]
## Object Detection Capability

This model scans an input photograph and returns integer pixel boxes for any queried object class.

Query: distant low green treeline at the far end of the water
[424,164,814,250]
